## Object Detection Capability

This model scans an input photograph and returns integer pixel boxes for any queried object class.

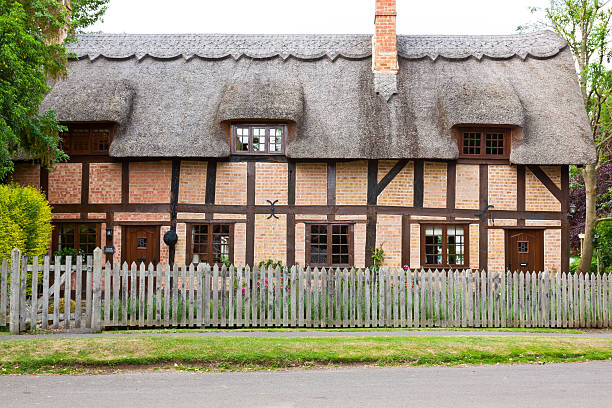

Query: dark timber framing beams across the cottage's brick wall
[45,157,569,270]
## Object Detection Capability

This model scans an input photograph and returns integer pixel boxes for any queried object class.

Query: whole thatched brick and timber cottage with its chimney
[9,0,595,271]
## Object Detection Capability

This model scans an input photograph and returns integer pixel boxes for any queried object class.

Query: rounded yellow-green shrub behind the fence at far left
[0,184,52,259]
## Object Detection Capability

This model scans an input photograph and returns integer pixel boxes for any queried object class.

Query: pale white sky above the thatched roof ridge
[87,0,550,34]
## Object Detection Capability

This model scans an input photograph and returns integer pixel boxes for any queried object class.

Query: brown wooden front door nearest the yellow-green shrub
[121,226,159,264]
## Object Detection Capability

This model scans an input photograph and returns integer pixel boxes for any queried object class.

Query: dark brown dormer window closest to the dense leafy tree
[61,124,112,156]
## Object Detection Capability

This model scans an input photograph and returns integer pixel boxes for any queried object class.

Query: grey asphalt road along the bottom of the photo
[0,362,612,408]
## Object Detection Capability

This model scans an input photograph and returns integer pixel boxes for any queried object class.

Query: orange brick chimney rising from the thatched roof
[372,0,399,101]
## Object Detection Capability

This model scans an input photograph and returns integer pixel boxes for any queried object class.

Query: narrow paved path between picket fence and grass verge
[0,330,612,341]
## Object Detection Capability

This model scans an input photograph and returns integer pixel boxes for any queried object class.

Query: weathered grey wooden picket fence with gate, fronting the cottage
[0,249,612,332]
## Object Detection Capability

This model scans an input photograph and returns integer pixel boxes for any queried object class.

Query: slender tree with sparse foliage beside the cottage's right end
[532,0,612,273]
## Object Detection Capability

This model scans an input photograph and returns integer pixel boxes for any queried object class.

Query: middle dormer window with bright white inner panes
[232,124,287,155]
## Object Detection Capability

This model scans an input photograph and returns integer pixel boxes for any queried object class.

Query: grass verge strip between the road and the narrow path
[0,336,612,374]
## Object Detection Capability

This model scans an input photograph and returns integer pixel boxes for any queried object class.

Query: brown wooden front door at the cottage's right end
[506,230,544,272]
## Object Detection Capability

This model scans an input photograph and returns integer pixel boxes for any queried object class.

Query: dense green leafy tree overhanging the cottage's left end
[0,0,109,180]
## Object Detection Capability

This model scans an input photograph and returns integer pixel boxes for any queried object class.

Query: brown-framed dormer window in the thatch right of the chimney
[457,127,510,159]
